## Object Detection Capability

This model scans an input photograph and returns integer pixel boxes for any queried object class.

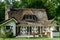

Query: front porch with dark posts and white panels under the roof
[16,25,50,37]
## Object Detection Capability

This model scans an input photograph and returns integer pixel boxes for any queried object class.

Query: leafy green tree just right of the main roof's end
[45,2,56,19]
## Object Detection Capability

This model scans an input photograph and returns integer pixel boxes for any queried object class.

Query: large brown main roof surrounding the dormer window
[8,8,52,25]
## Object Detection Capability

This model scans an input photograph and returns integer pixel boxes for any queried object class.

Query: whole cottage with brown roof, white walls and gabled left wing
[0,4,60,38]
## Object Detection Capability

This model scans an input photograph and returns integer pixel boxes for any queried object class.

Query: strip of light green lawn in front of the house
[0,38,60,40]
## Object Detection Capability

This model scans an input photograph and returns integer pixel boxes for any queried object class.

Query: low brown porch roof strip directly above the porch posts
[17,21,51,27]
